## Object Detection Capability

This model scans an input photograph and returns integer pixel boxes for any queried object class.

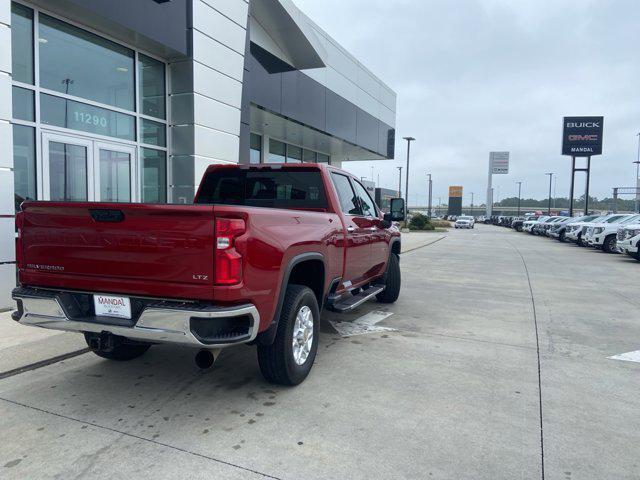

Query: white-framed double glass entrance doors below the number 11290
[42,132,140,202]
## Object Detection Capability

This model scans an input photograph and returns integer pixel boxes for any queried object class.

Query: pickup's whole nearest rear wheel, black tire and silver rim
[258,285,320,385]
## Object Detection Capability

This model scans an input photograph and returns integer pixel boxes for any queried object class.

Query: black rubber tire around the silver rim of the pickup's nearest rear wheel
[258,285,320,386]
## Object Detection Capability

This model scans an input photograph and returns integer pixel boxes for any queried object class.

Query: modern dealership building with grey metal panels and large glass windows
[0,0,396,309]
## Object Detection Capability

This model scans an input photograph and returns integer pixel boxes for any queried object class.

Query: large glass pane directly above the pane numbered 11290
[38,13,135,111]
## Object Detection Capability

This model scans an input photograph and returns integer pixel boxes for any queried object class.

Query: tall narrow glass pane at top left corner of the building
[11,3,33,85]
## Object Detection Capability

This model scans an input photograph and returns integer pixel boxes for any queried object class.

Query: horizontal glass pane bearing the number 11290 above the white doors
[40,93,136,140]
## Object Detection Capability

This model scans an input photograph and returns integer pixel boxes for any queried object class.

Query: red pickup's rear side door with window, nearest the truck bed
[331,172,372,289]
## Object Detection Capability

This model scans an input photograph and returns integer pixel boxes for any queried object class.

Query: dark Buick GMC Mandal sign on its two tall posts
[562,117,604,216]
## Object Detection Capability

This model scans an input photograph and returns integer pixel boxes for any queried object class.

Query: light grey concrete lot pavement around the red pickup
[0,225,640,480]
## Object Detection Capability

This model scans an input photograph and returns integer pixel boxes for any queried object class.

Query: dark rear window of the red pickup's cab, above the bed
[196,169,327,209]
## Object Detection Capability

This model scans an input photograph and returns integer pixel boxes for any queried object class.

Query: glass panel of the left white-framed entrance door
[49,142,87,202]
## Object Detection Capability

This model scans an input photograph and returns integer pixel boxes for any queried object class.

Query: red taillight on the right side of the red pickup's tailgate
[214,218,245,285]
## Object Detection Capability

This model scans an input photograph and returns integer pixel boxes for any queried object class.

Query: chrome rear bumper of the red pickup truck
[12,287,260,348]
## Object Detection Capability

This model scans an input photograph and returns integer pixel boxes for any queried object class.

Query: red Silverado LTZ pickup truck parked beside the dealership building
[13,164,404,385]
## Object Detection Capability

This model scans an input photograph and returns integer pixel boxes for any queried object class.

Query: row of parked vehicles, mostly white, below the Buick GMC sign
[485,213,640,261]
